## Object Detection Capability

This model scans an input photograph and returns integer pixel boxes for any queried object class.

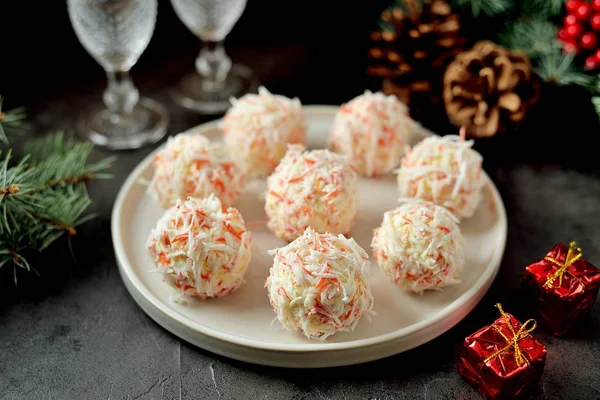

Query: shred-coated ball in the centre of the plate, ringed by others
[265,145,358,242]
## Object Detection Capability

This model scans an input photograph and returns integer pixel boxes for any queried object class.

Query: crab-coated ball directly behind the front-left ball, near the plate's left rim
[148,135,246,208]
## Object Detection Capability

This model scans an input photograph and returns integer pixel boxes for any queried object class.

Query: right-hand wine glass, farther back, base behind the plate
[171,0,258,113]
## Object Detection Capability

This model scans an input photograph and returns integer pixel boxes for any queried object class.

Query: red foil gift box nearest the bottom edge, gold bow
[458,304,546,399]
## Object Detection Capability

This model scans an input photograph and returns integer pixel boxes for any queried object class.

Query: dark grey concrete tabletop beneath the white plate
[0,50,600,400]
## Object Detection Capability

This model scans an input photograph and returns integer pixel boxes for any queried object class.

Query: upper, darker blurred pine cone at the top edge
[367,0,466,119]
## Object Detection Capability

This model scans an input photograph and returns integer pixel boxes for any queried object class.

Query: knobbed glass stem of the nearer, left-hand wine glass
[103,71,140,122]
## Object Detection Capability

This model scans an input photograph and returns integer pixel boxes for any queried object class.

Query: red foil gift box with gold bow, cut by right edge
[524,242,600,336]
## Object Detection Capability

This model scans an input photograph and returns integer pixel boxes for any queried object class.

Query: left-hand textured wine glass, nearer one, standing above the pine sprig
[67,0,169,150]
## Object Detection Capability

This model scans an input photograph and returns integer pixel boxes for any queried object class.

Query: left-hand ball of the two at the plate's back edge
[221,87,306,178]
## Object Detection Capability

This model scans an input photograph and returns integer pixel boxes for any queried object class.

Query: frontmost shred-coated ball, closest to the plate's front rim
[265,228,374,340]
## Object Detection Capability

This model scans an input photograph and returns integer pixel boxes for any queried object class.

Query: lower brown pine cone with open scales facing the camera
[444,41,537,137]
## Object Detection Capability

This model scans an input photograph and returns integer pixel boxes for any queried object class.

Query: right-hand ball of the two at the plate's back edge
[329,91,415,177]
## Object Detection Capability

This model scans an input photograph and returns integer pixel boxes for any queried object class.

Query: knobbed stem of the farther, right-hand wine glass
[196,41,231,92]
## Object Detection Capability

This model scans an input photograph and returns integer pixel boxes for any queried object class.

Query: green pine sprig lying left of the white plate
[0,132,114,283]
